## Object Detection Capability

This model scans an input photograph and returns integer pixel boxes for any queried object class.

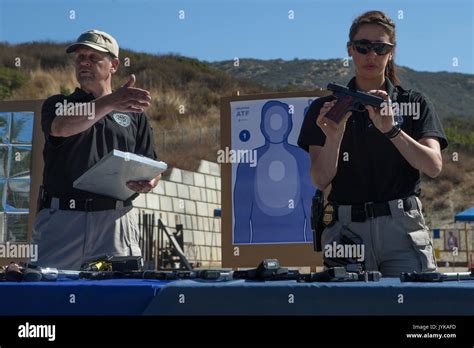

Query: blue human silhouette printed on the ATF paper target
[233,101,314,244]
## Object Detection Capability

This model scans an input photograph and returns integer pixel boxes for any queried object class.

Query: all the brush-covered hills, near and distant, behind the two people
[0,43,474,226]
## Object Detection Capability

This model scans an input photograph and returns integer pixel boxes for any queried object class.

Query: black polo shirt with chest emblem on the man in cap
[41,88,157,199]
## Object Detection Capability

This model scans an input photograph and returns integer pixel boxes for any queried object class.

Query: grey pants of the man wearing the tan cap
[33,206,141,270]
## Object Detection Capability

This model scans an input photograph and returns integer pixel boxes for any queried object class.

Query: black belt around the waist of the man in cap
[39,190,135,212]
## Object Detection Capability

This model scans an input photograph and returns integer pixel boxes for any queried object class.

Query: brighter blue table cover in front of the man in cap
[0,279,168,316]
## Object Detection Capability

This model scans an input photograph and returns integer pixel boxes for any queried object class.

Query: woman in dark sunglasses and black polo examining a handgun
[298,11,447,277]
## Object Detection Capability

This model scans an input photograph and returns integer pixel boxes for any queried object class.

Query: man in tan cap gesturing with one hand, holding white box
[33,30,160,269]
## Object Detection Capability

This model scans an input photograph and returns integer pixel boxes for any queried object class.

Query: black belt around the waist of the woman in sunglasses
[332,196,416,222]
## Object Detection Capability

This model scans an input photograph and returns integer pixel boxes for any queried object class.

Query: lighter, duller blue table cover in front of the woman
[144,278,474,315]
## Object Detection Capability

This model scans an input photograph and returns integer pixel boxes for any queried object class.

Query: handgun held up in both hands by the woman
[326,83,384,123]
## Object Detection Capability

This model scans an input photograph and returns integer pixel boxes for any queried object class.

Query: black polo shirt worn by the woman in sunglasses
[298,78,448,204]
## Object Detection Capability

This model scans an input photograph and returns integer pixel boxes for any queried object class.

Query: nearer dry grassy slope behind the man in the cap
[0,43,264,170]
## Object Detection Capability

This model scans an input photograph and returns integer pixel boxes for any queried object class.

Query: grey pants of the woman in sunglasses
[321,196,436,277]
